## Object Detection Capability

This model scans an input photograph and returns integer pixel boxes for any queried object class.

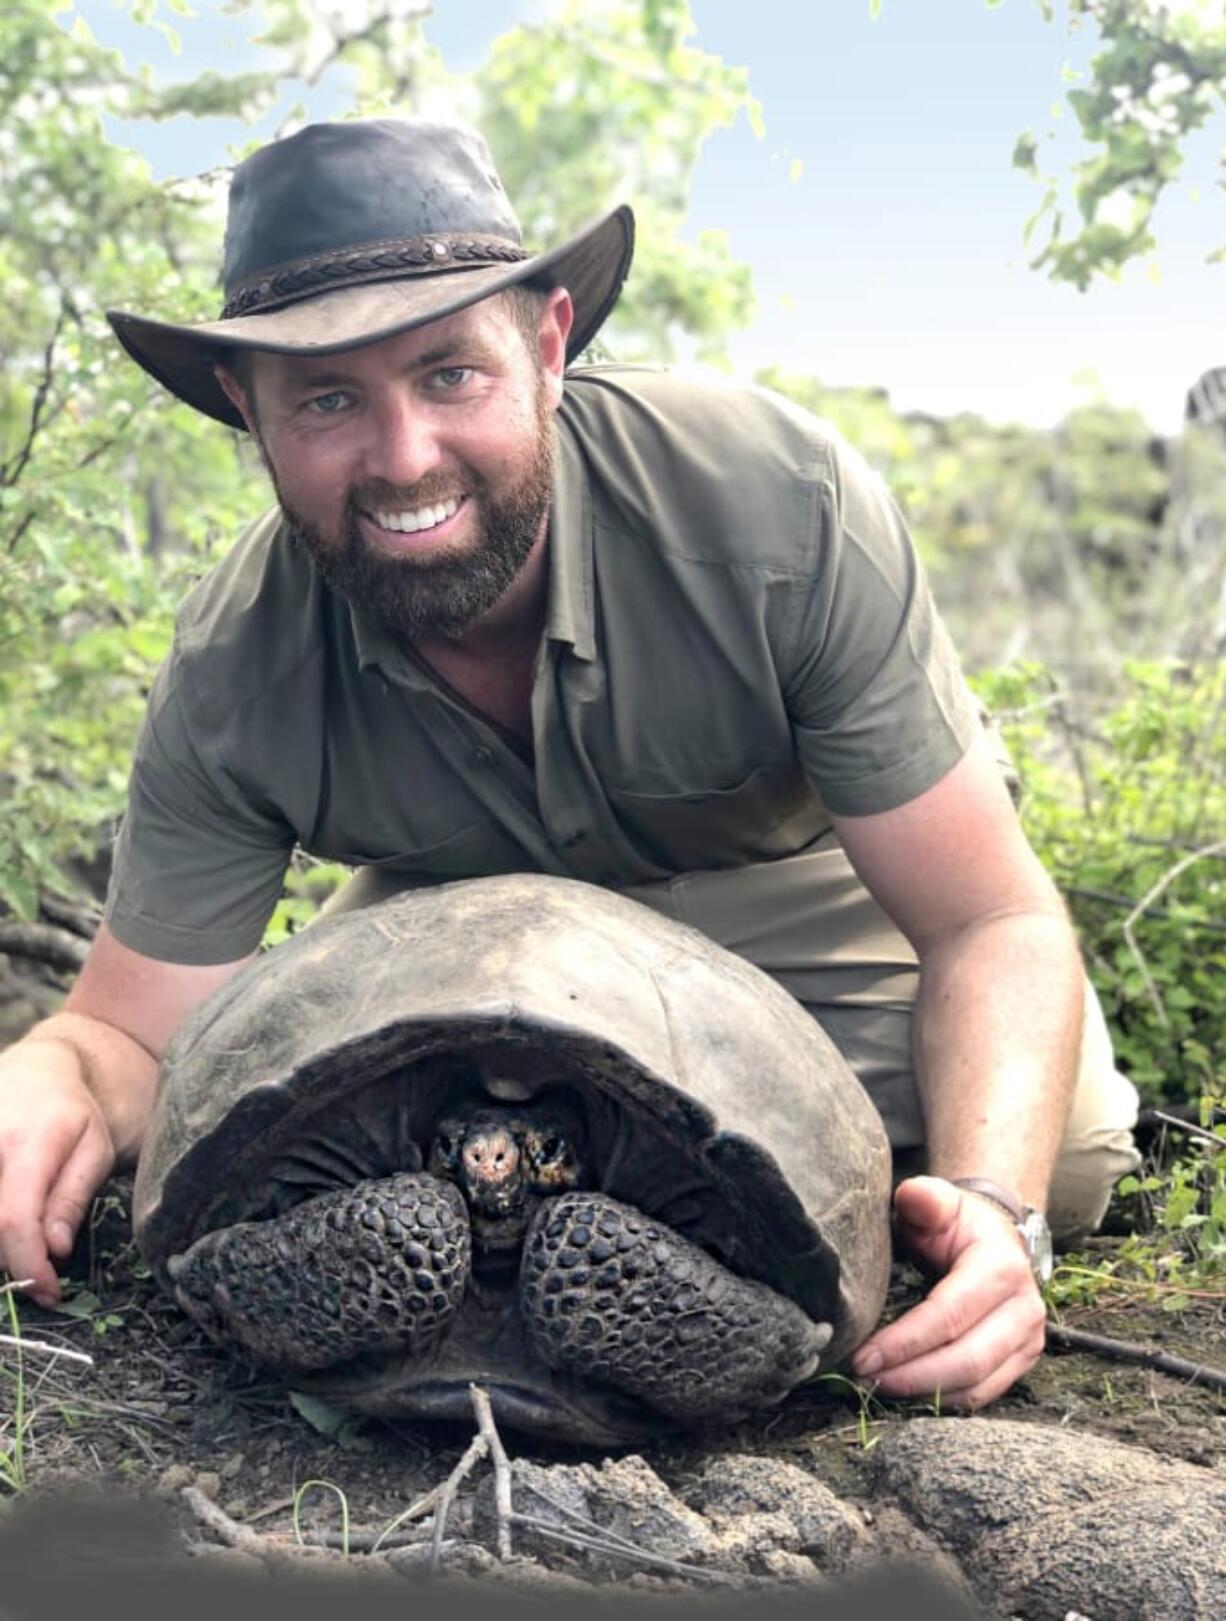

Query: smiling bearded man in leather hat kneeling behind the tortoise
[0,120,1135,1407]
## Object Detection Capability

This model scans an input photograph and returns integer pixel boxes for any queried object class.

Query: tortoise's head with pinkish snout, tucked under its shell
[427,1094,589,1250]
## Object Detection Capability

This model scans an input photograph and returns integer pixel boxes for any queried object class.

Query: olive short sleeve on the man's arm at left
[105,653,294,966]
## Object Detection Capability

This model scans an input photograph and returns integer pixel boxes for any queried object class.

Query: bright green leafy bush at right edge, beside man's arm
[975,661,1226,1102]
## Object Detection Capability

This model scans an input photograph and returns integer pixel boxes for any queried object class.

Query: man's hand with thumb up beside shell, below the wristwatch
[851,1177,1046,1407]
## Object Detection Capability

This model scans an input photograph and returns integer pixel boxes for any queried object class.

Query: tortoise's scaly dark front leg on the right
[521,1193,830,1422]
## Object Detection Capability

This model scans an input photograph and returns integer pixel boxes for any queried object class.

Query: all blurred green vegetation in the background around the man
[0,0,1226,1266]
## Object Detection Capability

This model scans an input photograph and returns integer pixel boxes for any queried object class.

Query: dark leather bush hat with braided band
[107,118,634,428]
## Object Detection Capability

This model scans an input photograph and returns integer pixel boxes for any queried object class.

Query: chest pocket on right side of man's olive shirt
[608,762,830,872]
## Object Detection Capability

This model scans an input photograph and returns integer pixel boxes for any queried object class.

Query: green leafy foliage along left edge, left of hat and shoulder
[0,0,269,916]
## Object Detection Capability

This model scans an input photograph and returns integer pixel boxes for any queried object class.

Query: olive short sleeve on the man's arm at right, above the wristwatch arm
[783,438,980,815]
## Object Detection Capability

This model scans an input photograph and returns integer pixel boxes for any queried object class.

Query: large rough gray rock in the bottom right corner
[874,1418,1226,1621]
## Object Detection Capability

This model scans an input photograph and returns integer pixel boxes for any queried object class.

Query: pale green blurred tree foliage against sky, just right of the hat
[475,0,761,361]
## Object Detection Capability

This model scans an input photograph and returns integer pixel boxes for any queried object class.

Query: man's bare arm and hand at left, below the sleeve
[0,926,250,1305]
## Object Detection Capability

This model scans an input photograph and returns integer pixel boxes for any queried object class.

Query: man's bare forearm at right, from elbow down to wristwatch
[915,911,1085,1208]
